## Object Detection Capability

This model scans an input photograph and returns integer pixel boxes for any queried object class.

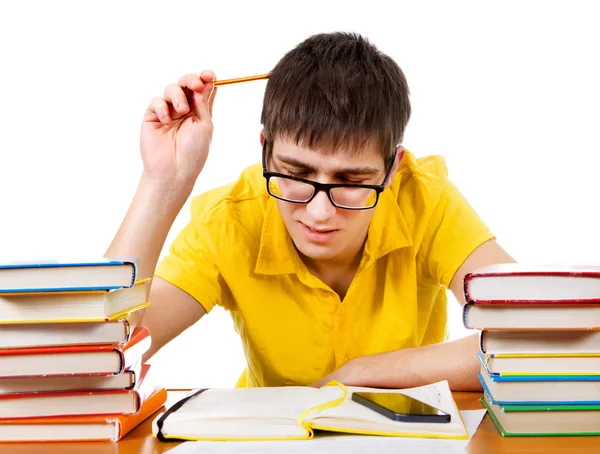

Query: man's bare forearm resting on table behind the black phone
[356,334,481,391]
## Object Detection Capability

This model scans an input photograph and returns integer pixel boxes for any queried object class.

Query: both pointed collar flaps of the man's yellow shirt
[254,183,412,275]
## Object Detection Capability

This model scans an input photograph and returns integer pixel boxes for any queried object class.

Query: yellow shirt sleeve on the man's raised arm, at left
[155,197,226,312]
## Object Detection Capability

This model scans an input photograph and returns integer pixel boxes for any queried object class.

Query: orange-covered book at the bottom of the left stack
[0,387,167,442]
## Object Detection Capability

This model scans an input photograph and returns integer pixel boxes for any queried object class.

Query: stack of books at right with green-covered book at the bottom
[463,264,600,436]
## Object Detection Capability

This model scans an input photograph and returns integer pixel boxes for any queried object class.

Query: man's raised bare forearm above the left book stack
[105,177,187,279]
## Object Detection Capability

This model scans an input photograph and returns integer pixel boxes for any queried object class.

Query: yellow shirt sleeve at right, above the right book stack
[418,178,495,288]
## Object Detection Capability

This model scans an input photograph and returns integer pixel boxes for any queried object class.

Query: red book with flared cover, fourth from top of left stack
[0,327,151,378]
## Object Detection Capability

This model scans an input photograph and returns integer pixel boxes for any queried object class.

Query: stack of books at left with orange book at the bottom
[0,260,166,442]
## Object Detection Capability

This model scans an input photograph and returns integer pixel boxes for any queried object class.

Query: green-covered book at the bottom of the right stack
[481,393,600,437]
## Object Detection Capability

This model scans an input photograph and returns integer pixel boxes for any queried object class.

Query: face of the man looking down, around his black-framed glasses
[267,139,393,262]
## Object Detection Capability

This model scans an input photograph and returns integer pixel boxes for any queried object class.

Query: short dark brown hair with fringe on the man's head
[261,32,411,161]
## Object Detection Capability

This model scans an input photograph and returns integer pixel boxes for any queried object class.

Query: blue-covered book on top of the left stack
[0,259,137,294]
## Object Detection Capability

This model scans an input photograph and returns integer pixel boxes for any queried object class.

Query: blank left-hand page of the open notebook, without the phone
[154,386,344,439]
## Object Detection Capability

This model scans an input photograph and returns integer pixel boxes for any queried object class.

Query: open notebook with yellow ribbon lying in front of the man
[152,381,468,440]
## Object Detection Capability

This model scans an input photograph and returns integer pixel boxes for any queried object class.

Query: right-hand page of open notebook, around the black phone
[307,381,467,438]
